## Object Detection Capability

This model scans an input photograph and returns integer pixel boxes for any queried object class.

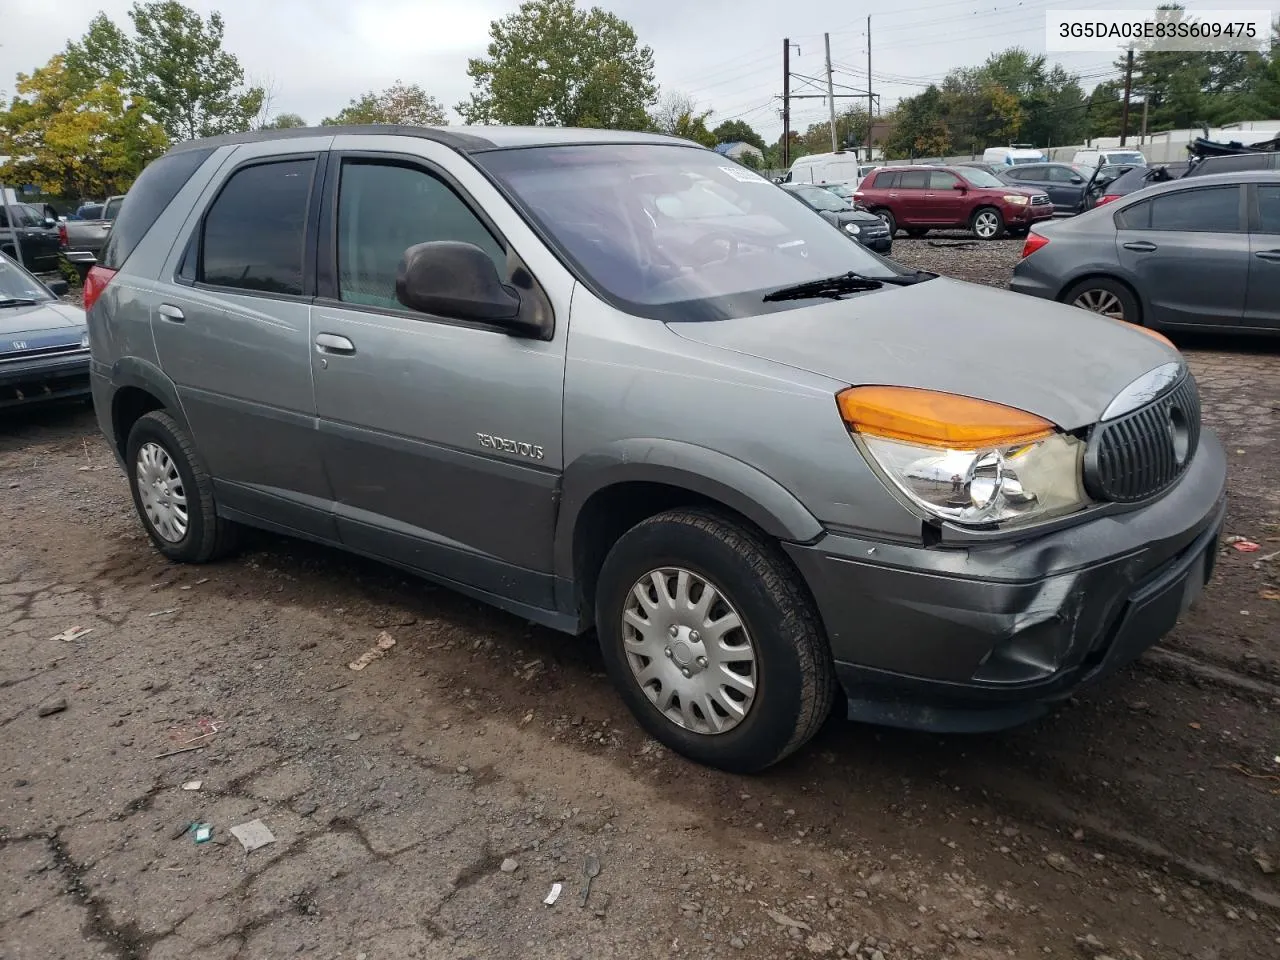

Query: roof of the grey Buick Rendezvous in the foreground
[170,124,696,154]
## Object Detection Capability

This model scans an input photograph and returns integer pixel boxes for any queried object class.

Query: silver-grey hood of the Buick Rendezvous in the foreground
[671,278,1178,430]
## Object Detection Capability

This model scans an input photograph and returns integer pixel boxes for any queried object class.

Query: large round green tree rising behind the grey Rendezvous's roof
[456,0,658,129]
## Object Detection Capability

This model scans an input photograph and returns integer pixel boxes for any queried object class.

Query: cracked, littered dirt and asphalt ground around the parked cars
[0,238,1280,960]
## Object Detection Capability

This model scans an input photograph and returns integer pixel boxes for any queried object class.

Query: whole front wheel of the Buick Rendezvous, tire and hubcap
[595,509,836,773]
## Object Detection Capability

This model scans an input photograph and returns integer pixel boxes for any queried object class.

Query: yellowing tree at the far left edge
[0,55,168,198]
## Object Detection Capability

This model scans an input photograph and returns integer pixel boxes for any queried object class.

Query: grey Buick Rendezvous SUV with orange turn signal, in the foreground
[86,127,1226,771]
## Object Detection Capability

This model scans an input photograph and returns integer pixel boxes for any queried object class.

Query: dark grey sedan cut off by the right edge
[1010,172,1280,334]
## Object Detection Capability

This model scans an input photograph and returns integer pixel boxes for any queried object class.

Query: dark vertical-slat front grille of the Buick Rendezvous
[1084,374,1201,503]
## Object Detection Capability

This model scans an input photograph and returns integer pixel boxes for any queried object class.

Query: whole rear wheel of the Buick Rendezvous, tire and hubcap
[125,411,237,563]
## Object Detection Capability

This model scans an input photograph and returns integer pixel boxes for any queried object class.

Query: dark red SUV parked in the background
[854,166,1053,239]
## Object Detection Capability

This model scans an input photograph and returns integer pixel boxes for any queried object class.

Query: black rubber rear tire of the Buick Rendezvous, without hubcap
[125,410,237,563]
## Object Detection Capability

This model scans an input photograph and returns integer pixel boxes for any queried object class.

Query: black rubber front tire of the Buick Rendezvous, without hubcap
[595,509,836,773]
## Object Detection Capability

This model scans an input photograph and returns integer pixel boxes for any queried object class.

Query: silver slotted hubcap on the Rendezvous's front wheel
[622,567,756,733]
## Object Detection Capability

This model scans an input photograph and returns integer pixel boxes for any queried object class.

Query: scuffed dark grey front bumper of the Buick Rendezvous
[787,430,1226,732]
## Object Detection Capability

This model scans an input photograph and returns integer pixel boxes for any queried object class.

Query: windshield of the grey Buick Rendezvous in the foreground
[476,143,910,320]
